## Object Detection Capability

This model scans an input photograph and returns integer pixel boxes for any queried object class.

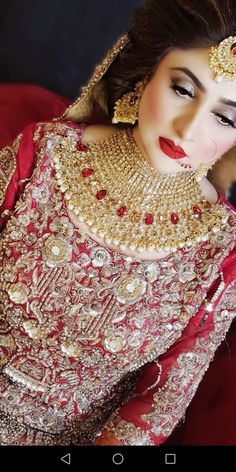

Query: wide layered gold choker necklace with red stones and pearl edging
[53,129,227,253]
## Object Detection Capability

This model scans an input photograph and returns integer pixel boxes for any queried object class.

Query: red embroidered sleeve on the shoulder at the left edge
[0,123,40,231]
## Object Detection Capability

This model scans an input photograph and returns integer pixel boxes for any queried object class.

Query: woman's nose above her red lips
[173,108,204,145]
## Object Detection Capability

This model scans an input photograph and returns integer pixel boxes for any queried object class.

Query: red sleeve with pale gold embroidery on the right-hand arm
[95,249,236,445]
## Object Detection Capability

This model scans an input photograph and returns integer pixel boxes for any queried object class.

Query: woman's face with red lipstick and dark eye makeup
[134,49,236,172]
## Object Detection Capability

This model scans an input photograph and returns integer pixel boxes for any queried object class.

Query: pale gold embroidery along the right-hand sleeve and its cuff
[106,281,236,445]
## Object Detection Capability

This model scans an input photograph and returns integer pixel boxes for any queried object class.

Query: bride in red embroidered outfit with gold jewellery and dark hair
[0,0,236,445]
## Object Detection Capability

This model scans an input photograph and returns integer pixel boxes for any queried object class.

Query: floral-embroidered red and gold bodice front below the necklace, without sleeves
[0,123,235,444]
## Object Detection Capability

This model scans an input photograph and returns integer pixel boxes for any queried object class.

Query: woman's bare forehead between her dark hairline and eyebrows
[156,48,236,100]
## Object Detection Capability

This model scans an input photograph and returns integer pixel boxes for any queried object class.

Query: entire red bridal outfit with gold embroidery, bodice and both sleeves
[0,117,236,445]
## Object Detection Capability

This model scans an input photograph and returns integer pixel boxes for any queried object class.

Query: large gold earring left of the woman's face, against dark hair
[112,79,147,124]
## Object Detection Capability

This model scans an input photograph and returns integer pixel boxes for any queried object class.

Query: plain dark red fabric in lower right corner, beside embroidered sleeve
[165,322,236,446]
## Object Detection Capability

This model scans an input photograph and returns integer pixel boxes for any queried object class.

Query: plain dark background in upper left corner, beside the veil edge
[0,0,143,99]
